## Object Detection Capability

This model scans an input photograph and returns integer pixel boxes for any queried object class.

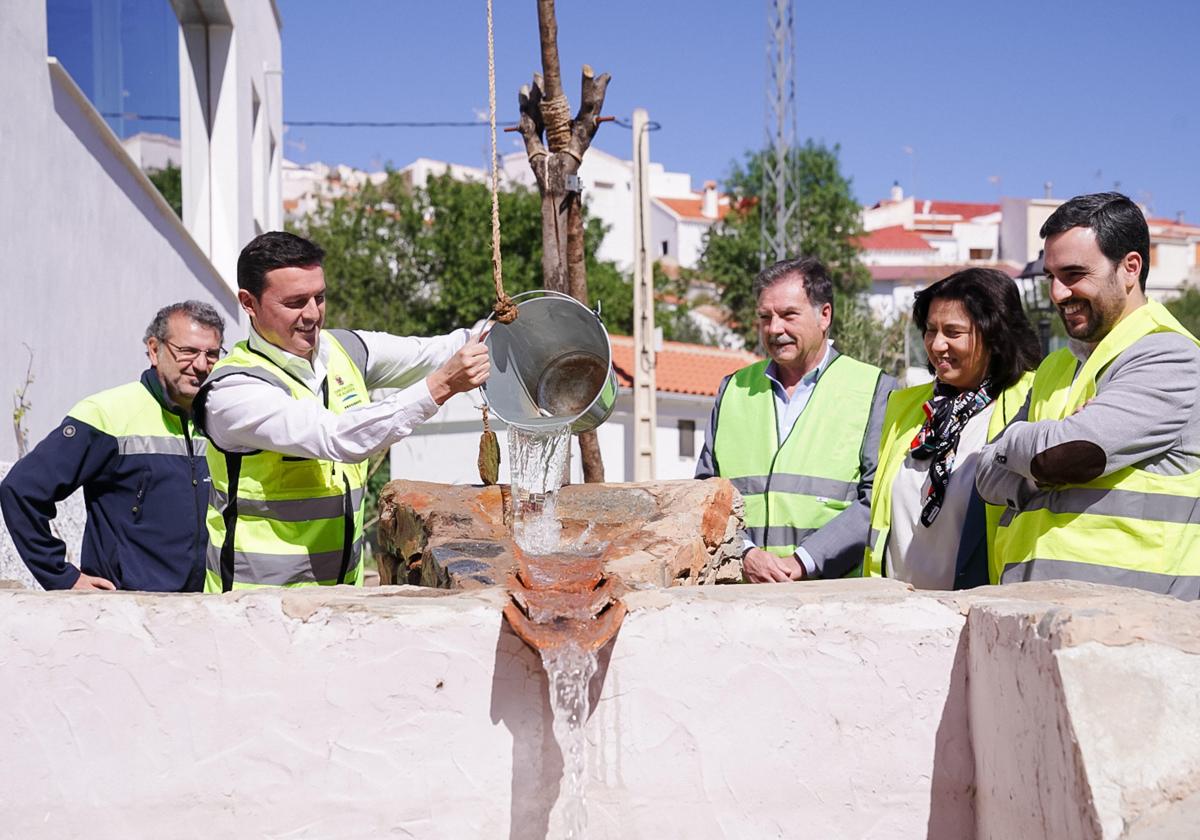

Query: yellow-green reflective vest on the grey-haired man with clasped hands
[713,355,882,557]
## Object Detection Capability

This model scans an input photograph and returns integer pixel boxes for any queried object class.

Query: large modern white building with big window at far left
[0,0,283,461]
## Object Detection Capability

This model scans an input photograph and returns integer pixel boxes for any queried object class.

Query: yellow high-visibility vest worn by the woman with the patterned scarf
[863,373,1033,583]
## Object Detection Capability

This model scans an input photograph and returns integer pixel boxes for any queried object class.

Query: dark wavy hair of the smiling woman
[912,269,1042,397]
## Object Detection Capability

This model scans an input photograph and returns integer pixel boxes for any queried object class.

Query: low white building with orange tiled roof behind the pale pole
[391,336,758,484]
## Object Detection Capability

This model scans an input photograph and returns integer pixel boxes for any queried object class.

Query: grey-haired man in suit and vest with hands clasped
[696,258,896,583]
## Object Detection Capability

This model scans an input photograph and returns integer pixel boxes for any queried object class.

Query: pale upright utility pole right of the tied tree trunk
[634,108,658,481]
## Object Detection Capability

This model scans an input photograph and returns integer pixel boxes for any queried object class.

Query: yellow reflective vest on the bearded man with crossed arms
[996,301,1200,600]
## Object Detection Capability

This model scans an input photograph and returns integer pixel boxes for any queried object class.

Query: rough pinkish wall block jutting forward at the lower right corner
[968,582,1200,840]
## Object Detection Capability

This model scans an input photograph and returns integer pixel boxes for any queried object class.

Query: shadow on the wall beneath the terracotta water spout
[491,619,619,840]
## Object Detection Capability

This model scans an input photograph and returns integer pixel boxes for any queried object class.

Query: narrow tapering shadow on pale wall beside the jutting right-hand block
[925,632,976,840]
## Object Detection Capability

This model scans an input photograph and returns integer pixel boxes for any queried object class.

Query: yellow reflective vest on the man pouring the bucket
[197,331,370,592]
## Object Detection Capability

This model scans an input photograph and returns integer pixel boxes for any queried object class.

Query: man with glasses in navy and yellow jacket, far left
[0,300,224,592]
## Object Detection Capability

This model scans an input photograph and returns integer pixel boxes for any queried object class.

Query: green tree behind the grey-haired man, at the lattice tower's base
[700,140,906,370]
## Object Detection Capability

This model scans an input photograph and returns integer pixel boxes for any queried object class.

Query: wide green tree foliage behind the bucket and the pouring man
[290,172,632,335]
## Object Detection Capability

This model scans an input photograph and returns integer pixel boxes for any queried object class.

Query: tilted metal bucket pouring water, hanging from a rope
[482,289,617,434]
